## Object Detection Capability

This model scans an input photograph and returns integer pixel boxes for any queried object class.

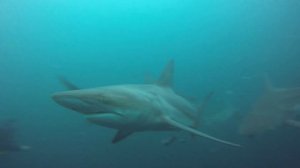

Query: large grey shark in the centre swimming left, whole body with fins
[52,60,240,147]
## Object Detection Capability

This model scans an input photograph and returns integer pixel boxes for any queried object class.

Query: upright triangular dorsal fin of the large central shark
[156,60,174,87]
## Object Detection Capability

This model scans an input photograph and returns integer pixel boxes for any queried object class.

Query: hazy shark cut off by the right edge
[239,77,300,136]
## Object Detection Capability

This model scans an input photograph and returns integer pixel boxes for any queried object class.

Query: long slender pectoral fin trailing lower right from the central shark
[164,117,241,147]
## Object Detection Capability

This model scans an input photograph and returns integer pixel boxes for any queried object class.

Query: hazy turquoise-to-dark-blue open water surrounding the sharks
[0,0,300,168]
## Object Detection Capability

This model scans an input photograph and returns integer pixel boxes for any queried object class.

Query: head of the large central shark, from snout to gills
[52,86,154,128]
